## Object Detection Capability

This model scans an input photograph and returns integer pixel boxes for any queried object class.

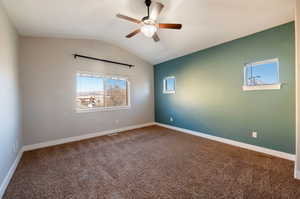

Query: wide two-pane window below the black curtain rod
[76,73,129,111]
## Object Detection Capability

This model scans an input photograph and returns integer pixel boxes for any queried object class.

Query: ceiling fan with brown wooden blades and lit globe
[117,0,182,42]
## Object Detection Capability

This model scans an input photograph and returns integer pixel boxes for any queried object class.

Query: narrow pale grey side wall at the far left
[0,2,22,192]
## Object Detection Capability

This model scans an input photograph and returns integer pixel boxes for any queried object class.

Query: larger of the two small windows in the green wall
[243,59,281,90]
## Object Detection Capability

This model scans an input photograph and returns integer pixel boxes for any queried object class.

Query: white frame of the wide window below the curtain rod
[75,71,131,113]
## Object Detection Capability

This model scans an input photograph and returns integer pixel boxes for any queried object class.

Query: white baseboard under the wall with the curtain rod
[23,122,155,151]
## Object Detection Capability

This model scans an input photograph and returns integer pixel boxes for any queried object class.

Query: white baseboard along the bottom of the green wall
[156,123,300,162]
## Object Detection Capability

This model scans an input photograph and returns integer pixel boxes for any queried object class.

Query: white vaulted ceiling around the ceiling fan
[1,0,295,64]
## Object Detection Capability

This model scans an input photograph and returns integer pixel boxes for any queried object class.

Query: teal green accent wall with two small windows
[155,22,295,154]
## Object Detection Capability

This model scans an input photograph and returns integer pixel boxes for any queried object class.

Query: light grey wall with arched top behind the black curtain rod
[20,37,154,145]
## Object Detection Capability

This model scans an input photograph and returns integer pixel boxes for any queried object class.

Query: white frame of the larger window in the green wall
[243,58,281,91]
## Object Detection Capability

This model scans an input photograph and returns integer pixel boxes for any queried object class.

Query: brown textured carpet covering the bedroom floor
[4,126,300,199]
